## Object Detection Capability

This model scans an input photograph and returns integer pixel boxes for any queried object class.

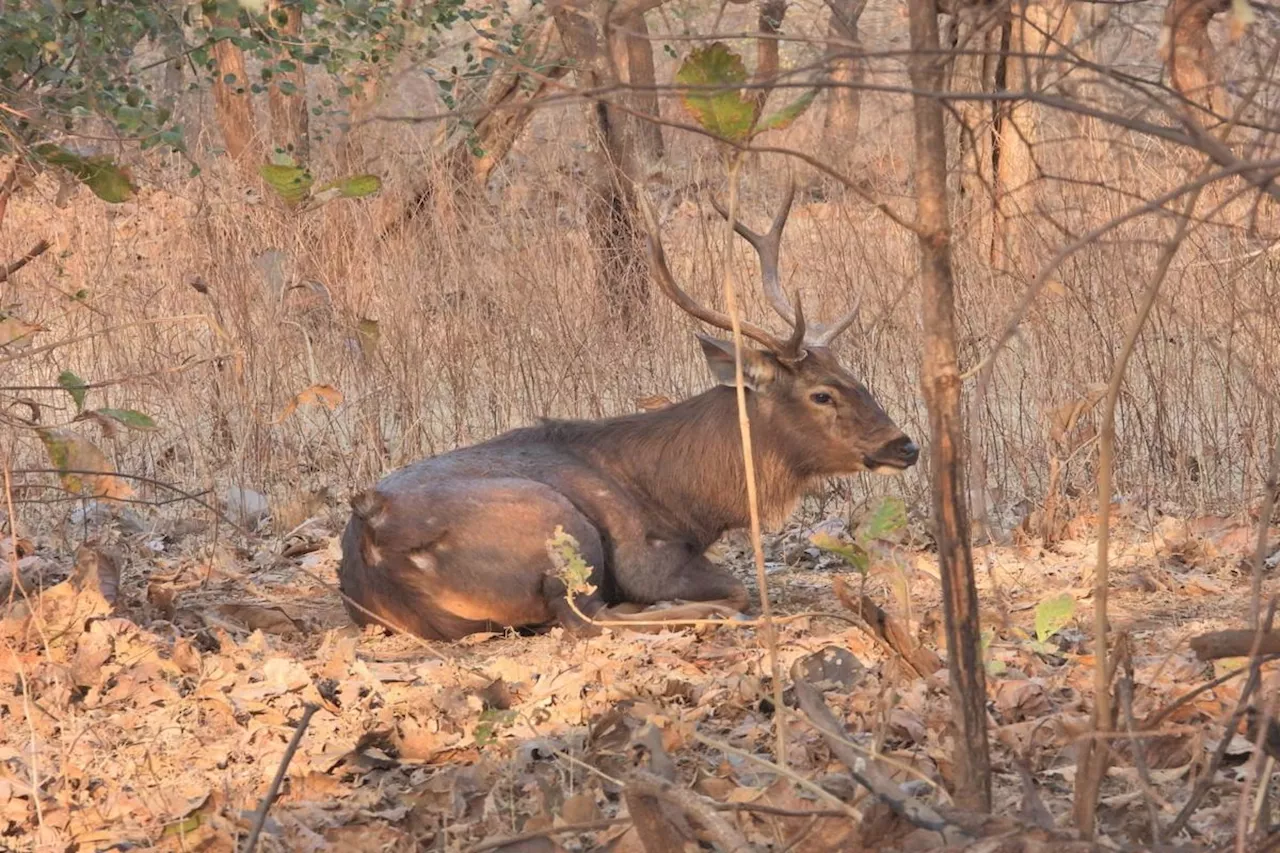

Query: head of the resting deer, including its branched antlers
[640,182,919,476]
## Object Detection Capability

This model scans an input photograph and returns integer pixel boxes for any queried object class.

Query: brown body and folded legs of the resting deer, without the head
[339,388,762,640]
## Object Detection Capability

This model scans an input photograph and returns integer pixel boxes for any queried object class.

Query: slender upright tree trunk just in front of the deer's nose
[908,0,991,812]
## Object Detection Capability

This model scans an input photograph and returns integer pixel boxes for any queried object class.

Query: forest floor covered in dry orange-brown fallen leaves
[0,499,1276,853]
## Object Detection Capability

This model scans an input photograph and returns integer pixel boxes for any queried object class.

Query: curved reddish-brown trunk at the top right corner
[1160,0,1231,126]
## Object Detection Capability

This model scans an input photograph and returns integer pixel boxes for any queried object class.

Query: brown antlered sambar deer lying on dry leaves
[339,186,919,640]
